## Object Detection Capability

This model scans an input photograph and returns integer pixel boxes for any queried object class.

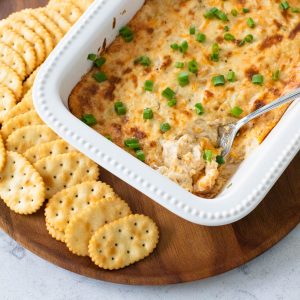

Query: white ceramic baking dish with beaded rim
[33,0,300,226]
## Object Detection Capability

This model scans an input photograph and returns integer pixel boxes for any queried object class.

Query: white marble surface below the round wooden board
[0,225,300,300]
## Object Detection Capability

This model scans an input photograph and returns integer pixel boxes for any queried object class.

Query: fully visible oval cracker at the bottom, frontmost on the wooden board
[89,214,159,270]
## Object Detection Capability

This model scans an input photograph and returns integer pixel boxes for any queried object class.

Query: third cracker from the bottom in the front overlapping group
[45,181,116,231]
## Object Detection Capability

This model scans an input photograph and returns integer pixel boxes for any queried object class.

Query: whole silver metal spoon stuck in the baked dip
[218,88,300,157]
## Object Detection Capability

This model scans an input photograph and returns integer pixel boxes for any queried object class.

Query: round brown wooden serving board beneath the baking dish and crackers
[0,0,300,285]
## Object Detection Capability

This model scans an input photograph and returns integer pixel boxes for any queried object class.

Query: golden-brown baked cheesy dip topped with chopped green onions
[69,0,300,197]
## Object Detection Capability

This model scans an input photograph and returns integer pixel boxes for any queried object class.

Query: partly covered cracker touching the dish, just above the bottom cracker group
[33,152,99,199]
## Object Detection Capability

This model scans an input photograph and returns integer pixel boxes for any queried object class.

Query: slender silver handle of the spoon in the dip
[236,88,300,128]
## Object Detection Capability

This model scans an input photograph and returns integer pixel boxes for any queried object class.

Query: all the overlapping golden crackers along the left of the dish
[0,0,159,270]
